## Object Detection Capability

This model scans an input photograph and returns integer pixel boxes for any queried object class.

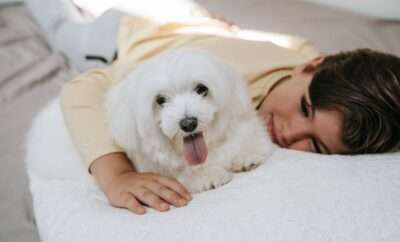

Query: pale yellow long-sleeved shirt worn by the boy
[61,16,318,167]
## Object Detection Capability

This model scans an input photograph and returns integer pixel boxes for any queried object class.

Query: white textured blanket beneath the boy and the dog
[26,100,400,242]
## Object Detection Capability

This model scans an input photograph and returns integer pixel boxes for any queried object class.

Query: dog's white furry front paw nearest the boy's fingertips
[178,166,233,193]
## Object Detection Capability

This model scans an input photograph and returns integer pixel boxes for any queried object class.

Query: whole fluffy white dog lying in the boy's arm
[106,48,273,192]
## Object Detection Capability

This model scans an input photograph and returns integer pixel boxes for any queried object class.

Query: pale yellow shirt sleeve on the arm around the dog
[61,68,123,171]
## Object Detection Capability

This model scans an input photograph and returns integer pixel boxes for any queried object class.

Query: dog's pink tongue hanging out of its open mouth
[183,133,208,165]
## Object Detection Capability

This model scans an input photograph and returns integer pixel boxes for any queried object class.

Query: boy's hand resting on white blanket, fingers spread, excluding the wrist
[105,171,192,214]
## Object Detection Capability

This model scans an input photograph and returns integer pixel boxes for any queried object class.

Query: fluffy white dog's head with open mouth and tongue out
[107,48,251,168]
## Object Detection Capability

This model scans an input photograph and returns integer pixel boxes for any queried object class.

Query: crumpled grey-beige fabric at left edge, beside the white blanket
[0,4,71,242]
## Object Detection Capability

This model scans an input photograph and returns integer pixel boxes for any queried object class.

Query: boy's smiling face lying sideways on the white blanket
[258,57,346,154]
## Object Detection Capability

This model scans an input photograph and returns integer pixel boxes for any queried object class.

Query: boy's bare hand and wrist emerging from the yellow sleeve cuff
[89,152,192,214]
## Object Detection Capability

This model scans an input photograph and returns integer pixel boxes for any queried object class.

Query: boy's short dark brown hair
[309,49,400,154]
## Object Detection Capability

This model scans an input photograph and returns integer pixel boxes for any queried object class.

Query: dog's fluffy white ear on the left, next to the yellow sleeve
[106,80,138,150]
